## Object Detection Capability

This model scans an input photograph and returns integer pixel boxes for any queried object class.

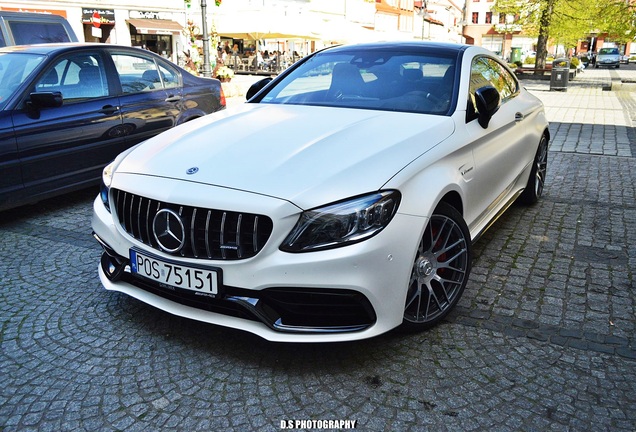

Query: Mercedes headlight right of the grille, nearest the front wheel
[280,191,400,252]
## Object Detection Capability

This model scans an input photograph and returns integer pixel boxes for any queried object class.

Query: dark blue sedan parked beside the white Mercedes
[0,44,225,210]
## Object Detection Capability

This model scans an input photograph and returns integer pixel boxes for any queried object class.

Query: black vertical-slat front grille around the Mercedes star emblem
[111,189,273,260]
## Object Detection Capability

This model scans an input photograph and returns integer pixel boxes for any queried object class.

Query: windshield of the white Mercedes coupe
[261,50,455,114]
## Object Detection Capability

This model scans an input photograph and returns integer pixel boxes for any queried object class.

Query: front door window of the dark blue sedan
[35,53,108,103]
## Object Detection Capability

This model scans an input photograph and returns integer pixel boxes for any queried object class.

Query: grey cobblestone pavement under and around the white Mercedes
[0,69,636,431]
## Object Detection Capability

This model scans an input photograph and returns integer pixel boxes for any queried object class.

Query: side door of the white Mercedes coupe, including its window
[466,56,538,228]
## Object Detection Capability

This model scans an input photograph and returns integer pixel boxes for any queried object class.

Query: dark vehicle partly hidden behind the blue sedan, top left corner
[0,10,78,47]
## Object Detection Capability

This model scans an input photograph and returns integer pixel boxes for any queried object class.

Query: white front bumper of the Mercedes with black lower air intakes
[92,191,425,342]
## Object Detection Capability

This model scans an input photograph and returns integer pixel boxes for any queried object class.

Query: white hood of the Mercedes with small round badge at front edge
[114,104,454,209]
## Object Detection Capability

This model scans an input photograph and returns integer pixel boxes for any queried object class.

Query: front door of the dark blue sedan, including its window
[13,50,124,197]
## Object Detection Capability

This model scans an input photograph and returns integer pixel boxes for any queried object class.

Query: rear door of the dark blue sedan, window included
[111,50,182,146]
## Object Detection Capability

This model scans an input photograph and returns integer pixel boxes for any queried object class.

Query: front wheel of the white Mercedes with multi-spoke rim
[400,203,472,331]
